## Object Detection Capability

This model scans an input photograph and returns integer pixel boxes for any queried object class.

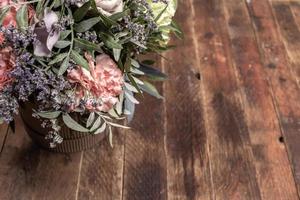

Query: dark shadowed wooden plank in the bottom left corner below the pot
[0,119,80,200]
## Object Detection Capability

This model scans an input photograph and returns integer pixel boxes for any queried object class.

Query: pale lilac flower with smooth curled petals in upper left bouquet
[34,10,60,57]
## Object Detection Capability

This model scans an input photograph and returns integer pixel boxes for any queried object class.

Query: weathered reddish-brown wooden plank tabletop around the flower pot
[0,0,300,200]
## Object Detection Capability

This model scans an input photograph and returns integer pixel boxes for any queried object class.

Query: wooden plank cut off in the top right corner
[272,2,300,86]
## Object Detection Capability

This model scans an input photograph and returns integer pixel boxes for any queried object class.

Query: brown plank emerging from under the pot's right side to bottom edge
[77,129,124,200]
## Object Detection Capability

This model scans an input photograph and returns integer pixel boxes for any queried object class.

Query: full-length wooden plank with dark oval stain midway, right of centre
[194,0,261,200]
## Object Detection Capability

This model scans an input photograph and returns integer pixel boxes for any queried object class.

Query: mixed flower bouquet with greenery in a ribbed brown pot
[0,0,181,152]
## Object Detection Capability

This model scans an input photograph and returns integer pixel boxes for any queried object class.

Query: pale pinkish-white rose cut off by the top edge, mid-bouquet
[95,0,124,16]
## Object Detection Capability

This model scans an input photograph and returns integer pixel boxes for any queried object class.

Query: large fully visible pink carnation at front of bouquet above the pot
[68,53,124,112]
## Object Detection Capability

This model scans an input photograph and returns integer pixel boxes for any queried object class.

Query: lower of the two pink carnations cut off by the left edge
[0,48,15,91]
